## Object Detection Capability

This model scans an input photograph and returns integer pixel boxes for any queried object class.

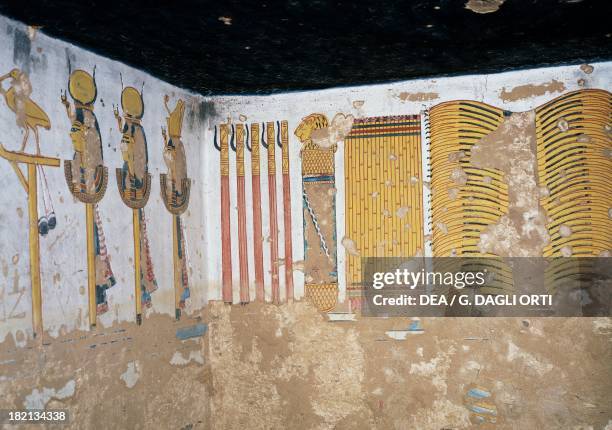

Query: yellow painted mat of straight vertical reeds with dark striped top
[343,115,424,308]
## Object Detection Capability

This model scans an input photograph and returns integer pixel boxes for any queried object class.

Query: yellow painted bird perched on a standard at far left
[0,69,51,155]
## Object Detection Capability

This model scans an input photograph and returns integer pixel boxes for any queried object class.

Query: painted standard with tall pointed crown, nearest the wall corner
[159,95,191,319]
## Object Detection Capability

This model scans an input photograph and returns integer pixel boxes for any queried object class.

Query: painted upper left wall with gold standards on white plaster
[0,18,210,343]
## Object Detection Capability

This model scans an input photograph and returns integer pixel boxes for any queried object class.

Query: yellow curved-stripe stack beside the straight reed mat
[429,101,508,257]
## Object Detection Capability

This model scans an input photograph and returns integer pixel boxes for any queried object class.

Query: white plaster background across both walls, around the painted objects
[0,17,612,341]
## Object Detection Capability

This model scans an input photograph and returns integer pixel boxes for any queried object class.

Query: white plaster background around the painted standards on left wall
[0,17,213,342]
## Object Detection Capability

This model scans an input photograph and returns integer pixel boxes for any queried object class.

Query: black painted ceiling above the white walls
[0,0,612,94]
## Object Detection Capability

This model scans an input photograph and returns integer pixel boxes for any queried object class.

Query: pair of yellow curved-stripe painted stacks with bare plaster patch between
[430,90,612,293]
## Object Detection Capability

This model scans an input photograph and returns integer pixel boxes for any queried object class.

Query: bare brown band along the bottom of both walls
[0,303,612,430]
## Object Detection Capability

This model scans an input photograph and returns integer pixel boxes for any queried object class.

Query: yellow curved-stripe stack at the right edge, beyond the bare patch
[536,90,612,257]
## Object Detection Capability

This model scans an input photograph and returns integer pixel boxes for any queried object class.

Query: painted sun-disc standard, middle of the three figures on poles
[114,87,157,324]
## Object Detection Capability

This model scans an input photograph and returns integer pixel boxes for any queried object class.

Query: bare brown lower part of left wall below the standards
[0,315,211,430]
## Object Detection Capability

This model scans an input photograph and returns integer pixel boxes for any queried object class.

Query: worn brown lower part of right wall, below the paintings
[209,303,612,430]
